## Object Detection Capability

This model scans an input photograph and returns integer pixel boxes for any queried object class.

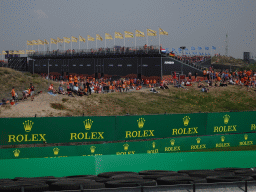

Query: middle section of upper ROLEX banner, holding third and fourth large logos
[116,113,207,140]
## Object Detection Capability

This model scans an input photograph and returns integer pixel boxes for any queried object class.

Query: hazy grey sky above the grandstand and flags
[0,0,256,59]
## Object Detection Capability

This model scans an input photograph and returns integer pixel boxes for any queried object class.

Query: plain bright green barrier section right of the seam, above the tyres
[95,151,256,174]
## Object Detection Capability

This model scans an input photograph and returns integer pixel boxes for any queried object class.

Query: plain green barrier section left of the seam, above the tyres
[0,157,96,179]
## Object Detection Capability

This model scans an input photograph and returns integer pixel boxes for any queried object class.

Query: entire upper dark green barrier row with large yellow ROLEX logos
[0,111,256,145]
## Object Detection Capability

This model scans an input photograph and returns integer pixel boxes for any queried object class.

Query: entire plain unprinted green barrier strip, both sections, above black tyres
[0,151,256,179]
